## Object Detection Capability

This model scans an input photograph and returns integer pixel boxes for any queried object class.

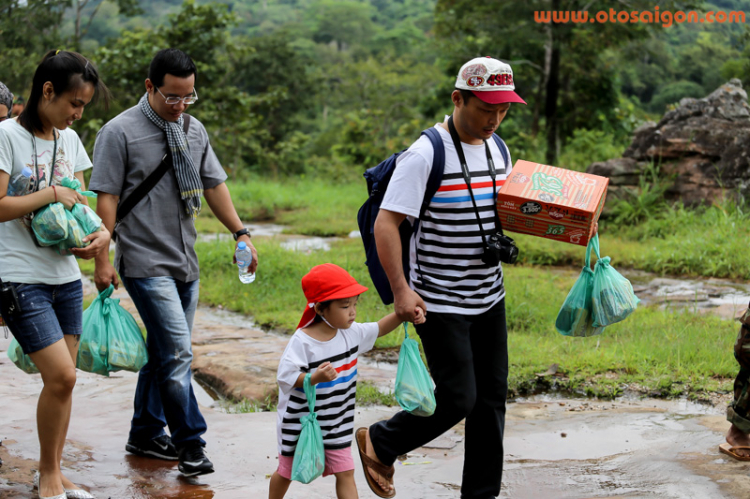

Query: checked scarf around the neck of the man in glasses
[138,92,203,220]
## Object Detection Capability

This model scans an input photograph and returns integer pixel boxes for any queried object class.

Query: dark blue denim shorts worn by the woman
[0,279,83,354]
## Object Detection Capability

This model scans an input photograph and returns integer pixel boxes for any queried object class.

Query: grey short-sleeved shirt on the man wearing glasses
[89,106,227,282]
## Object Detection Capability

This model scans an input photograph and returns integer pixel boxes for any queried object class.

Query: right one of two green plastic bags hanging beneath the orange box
[591,235,640,327]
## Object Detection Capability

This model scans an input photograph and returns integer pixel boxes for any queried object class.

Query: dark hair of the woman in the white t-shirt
[18,50,110,134]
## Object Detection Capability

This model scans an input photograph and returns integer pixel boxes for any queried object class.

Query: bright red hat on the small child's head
[297,263,367,329]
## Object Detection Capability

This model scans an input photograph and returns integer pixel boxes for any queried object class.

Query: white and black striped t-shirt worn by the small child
[276,322,379,456]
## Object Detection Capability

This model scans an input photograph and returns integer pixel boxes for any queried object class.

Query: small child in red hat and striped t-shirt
[268,263,425,499]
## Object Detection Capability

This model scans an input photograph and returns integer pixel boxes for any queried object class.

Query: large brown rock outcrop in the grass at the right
[586,78,750,206]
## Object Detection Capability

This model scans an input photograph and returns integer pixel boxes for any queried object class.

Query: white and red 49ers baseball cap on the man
[456,57,526,104]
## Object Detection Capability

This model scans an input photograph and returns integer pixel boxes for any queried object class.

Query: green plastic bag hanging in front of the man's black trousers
[395,322,435,416]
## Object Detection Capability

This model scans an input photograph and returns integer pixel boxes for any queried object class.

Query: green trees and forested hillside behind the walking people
[0,0,750,178]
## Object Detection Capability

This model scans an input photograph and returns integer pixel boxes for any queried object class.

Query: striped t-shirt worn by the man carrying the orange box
[381,124,512,315]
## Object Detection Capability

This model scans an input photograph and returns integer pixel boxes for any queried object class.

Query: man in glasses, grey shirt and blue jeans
[89,49,258,476]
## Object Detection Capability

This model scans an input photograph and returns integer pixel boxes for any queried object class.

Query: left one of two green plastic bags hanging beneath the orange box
[555,234,604,336]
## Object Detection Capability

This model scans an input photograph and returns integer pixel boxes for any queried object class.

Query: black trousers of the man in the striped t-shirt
[370,299,508,499]
